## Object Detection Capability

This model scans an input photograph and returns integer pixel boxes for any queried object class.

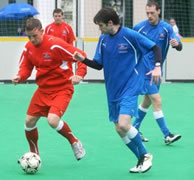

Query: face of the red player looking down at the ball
[26,28,44,46]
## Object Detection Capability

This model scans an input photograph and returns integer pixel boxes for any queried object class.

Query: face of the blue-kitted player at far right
[146,6,160,25]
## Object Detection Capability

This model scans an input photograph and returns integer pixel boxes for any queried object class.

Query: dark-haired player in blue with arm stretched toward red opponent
[74,8,162,173]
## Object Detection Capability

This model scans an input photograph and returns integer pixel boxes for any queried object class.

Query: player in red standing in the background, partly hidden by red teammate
[45,8,87,84]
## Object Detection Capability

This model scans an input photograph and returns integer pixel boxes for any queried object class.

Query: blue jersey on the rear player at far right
[134,20,180,68]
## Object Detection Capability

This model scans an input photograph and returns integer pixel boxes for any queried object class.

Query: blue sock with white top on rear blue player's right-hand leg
[153,111,169,137]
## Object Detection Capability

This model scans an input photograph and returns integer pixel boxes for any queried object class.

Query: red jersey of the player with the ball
[18,35,86,91]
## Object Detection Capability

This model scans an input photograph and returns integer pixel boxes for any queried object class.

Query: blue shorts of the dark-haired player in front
[108,96,138,122]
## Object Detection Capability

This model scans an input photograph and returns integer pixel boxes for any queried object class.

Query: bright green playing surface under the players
[0,83,194,180]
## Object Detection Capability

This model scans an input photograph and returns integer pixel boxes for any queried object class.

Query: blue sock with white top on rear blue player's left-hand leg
[133,105,148,131]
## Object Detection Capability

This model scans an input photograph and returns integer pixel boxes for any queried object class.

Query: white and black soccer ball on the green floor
[18,152,41,174]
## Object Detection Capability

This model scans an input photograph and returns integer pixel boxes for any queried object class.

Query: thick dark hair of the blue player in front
[93,8,120,25]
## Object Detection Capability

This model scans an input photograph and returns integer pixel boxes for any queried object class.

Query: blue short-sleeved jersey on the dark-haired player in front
[94,27,155,102]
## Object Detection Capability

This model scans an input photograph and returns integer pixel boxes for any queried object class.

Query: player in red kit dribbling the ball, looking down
[12,18,86,160]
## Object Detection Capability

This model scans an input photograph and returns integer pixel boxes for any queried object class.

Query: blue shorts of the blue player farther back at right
[142,79,160,95]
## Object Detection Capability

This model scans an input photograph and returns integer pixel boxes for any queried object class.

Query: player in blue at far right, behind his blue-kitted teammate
[133,1,182,145]
